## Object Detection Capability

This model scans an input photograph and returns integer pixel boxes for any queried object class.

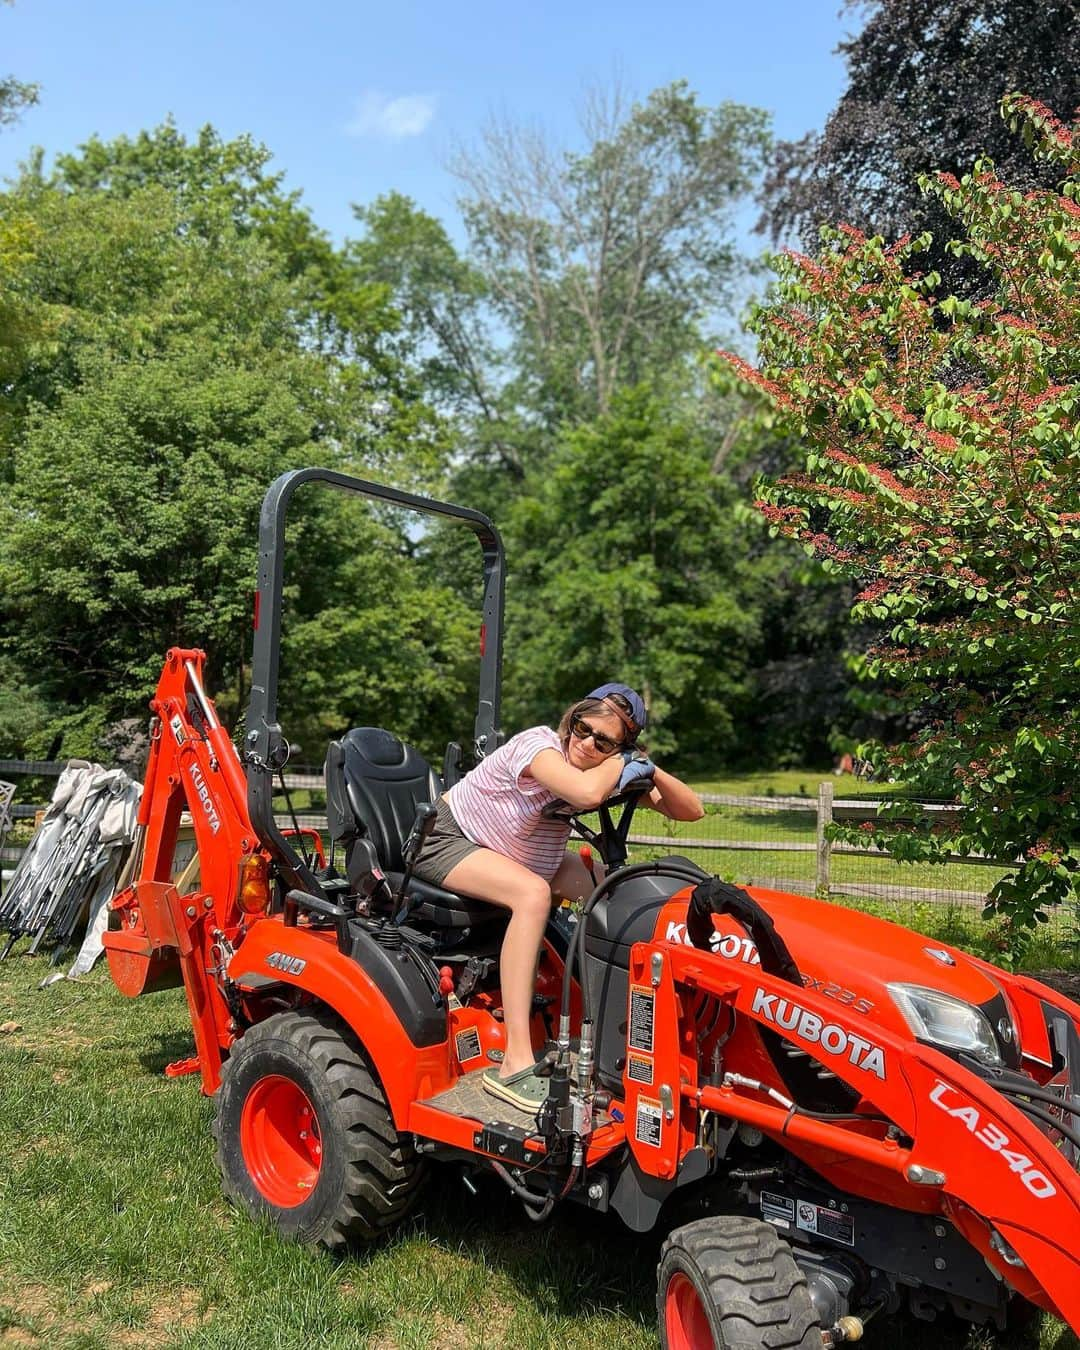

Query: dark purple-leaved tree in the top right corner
[761,0,1080,289]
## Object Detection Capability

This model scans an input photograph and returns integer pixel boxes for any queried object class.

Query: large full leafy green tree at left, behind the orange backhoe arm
[0,128,460,755]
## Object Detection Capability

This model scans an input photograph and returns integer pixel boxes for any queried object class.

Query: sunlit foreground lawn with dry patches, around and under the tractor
[0,949,1077,1350]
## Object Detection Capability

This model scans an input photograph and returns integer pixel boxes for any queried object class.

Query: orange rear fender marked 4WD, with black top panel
[228,917,450,1129]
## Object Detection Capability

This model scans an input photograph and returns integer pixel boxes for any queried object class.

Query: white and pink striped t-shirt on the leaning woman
[446,726,570,882]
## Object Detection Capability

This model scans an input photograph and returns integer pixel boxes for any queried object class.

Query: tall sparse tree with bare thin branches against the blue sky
[350,84,768,494]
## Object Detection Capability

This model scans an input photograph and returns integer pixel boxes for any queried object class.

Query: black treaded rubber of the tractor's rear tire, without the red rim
[213,1008,424,1249]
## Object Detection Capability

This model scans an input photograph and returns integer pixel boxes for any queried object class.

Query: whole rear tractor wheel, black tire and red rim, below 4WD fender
[213,1010,424,1249]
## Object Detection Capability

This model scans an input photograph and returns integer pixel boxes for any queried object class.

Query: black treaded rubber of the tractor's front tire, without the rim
[657,1215,822,1350]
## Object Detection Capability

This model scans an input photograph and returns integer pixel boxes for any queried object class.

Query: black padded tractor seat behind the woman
[324,726,501,929]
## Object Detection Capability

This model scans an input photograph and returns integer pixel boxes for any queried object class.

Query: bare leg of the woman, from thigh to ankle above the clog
[443,848,551,1079]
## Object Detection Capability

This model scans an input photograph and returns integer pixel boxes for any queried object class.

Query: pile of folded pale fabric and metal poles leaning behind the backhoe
[0,760,142,975]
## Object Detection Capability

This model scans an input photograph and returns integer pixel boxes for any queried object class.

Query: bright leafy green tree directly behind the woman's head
[506,389,756,764]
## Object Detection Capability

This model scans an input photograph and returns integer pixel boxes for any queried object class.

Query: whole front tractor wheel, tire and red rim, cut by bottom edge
[656,1215,822,1350]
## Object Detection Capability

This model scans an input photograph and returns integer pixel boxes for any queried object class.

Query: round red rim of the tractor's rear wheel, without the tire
[240,1073,323,1210]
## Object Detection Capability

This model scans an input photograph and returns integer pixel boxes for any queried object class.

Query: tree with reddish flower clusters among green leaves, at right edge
[724,96,1080,954]
